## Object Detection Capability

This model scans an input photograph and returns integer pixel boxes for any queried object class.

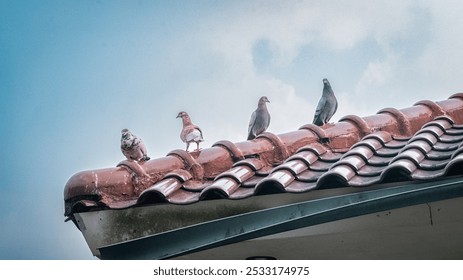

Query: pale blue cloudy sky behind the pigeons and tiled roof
[0,0,463,260]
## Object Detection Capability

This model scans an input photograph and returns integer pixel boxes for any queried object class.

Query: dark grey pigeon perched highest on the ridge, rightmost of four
[313,79,338,126]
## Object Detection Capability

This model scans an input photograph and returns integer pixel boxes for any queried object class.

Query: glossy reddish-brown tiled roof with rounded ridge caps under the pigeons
[64,93,463,216]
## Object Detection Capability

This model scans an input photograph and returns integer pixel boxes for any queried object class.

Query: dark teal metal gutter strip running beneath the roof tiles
[99,176,463,259]
